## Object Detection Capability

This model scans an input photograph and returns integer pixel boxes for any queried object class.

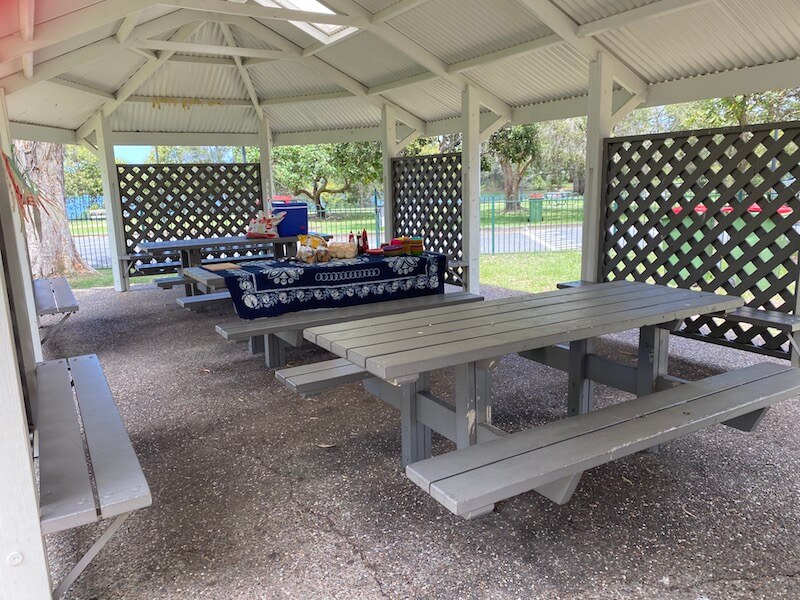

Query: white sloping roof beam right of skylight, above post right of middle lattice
[324,0,511,119]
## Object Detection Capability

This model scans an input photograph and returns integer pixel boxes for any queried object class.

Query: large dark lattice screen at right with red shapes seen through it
[601,122,800,358]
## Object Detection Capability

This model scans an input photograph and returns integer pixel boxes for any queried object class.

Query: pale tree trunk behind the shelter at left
[14,141,94,277]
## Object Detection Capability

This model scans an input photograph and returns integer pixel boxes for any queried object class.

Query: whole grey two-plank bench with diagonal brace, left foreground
[34,354,152,597]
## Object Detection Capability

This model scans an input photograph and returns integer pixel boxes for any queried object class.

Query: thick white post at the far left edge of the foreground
[0,189,50,600]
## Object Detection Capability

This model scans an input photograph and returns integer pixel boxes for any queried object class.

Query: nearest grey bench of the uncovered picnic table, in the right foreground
[406,363,800,516]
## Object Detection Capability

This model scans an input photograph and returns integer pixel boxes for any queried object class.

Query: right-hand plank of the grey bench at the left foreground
[68,354,152,519]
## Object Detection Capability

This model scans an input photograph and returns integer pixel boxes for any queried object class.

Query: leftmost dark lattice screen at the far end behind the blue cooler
[117,163,261,275]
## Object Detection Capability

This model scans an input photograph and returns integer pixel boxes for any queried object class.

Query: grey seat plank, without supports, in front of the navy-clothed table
[217,292,483,341]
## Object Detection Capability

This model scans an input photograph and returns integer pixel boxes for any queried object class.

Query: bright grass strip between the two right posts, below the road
[481,250,581,293]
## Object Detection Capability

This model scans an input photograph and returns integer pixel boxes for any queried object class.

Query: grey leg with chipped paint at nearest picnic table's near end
[454,362,492,449]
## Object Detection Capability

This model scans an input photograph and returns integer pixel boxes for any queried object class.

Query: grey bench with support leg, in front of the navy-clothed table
[217,292,483,369]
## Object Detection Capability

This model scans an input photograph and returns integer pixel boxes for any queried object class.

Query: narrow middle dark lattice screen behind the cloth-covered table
[392,153,463,285]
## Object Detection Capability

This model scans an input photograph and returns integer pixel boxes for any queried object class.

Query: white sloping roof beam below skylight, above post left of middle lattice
[222,19,425,131]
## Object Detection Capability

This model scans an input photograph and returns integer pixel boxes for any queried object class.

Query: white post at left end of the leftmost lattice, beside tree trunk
[95,111,130,292]
